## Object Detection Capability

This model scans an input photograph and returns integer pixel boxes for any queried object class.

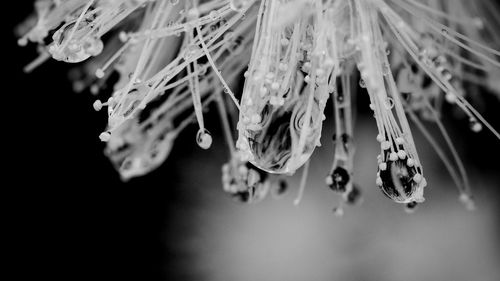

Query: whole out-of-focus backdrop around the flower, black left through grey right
[2,1,500,281]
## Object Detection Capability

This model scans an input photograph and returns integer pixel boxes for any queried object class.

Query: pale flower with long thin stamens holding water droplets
[19,0,500,213]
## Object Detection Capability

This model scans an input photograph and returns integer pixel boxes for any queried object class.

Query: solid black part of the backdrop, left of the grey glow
[6,1,186,280]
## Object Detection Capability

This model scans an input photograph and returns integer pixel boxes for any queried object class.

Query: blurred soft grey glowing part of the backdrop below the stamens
[161,115,500,281]
